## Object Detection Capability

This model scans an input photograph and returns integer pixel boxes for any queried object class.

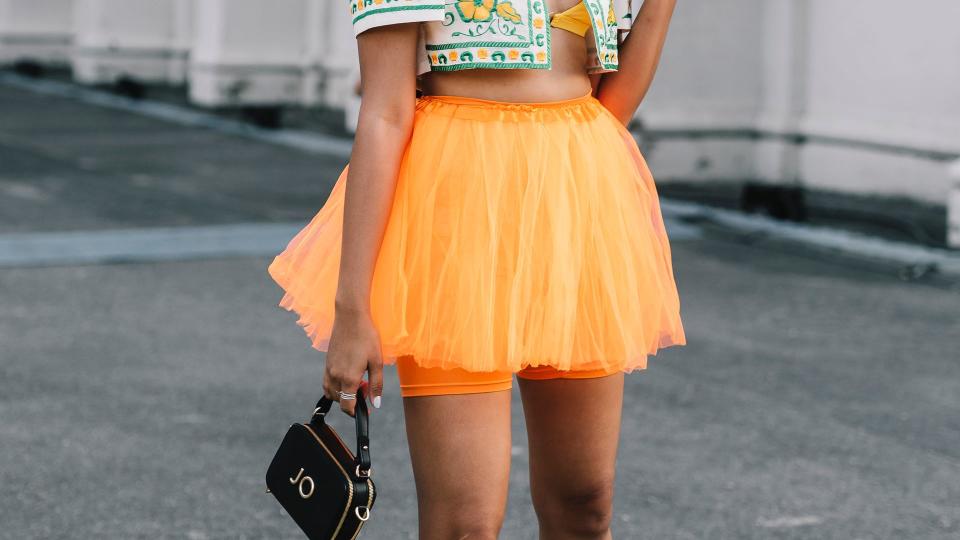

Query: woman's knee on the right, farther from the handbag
[535,478,613,538]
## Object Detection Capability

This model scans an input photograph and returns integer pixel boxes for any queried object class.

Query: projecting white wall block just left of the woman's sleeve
[190,0,358,107]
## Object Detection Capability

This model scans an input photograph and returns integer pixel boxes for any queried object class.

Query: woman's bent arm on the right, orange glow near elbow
[596,0,676,125]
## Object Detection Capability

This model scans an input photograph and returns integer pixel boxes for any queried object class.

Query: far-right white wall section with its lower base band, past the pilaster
[803,0,960,204]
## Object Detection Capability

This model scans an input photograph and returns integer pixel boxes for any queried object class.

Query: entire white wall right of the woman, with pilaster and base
[639,0,960,209]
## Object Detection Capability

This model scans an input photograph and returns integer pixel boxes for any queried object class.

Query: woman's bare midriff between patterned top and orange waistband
[420,0,591,102]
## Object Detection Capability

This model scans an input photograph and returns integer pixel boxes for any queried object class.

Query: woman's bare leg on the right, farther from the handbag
[518,373,623,540]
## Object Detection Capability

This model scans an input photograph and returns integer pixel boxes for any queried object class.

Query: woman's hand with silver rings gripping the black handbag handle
[323,309,383,416]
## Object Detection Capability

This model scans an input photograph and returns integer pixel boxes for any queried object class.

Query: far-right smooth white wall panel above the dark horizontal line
[804,0,960,151]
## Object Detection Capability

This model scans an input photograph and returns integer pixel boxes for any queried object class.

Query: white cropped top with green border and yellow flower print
[348,0,632,75]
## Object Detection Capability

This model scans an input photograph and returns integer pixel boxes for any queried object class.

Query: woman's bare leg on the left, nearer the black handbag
[403,390,510,540]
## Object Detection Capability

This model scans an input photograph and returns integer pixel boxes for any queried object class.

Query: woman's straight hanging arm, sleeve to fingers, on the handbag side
[323,23,419,416]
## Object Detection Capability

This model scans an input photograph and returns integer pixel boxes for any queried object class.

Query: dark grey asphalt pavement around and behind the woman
[0,78,960,540]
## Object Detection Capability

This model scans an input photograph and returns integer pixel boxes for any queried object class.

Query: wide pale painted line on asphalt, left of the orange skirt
[0,223,305,268]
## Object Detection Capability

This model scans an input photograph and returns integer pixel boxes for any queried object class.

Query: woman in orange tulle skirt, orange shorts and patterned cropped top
[269,0,685,539]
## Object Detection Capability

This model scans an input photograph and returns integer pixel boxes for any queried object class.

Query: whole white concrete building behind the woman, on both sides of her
[0,0,960,243]
